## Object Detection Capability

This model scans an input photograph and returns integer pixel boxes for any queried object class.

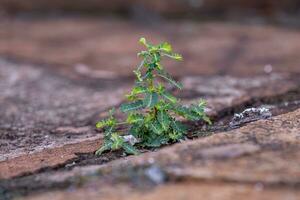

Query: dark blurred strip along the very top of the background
[0,0,300,21]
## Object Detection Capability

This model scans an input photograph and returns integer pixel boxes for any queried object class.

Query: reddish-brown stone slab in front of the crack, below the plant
[6,109,300,199]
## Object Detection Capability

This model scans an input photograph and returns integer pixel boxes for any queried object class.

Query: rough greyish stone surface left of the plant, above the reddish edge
[0,60,129,161]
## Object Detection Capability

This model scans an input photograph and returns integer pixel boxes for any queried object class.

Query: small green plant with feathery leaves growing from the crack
[96,38,210,155]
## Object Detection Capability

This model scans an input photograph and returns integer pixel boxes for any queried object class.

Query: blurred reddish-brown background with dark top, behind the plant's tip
[0,0,300,78]
